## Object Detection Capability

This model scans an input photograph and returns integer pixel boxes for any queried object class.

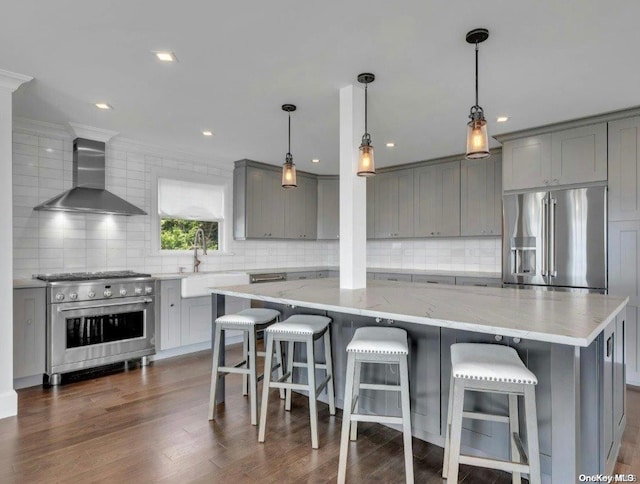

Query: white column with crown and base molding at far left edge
[0,69,32,418]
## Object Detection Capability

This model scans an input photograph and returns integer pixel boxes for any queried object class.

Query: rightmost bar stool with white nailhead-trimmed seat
[442,343,540,484]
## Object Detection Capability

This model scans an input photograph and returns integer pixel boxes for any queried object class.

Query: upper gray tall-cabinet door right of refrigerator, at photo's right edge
[608,116,640,221]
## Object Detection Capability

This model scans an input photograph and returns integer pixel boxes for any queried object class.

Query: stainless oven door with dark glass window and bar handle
[47,297,155,375]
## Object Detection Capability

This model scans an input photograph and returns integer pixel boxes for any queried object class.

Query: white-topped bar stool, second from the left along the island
[258,314,336,449]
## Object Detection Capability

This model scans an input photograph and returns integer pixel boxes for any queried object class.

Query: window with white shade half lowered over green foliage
[158,178,225,250]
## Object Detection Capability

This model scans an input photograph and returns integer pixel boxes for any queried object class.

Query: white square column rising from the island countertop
[340,85,367,289]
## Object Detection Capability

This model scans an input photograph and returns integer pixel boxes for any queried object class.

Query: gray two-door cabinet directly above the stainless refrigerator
[502,123,607,191]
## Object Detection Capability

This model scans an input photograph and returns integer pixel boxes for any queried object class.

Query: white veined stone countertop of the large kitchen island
[211,278,629,346]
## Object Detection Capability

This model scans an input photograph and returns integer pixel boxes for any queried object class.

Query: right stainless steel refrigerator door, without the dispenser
[548,187,607,289]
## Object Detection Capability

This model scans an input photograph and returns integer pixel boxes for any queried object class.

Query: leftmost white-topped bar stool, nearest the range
[209,308,284,425]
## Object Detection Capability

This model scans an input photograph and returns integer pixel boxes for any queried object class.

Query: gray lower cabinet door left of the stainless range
[13,288,46,378]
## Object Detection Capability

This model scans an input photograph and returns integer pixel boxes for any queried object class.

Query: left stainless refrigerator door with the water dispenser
[502,192,547,285]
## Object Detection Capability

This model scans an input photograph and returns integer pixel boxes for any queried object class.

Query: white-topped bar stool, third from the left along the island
[338,327,413,483]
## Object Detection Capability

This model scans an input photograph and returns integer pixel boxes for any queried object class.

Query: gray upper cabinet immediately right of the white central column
[368,169,414,239]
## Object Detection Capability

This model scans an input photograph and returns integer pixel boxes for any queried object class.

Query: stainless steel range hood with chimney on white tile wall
[34,138,147,215]
